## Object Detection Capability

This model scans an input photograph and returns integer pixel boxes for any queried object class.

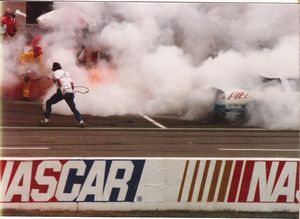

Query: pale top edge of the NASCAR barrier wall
[0,157,300,162]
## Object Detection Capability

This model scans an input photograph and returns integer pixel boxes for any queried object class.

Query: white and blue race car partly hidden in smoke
[213,77,300,123]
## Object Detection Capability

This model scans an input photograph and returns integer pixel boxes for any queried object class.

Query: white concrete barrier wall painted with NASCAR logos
[0,158,300,212]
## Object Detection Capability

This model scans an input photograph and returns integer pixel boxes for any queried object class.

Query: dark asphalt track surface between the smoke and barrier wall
[1,100,300,159]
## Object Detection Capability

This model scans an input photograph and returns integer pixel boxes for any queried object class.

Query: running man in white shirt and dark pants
[40,62,84,128]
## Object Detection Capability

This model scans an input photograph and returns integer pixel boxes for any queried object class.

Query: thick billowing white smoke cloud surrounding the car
[37,2,299,128]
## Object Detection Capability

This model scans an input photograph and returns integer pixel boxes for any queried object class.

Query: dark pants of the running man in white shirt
[45,89,82,122]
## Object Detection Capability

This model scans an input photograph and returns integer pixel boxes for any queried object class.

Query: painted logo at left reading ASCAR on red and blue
[0,160,145,203]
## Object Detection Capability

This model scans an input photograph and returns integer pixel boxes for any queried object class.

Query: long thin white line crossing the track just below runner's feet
[0,126,272,132]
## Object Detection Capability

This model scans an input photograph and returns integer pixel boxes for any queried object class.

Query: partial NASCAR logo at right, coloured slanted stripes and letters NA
[177,160,300,203]
